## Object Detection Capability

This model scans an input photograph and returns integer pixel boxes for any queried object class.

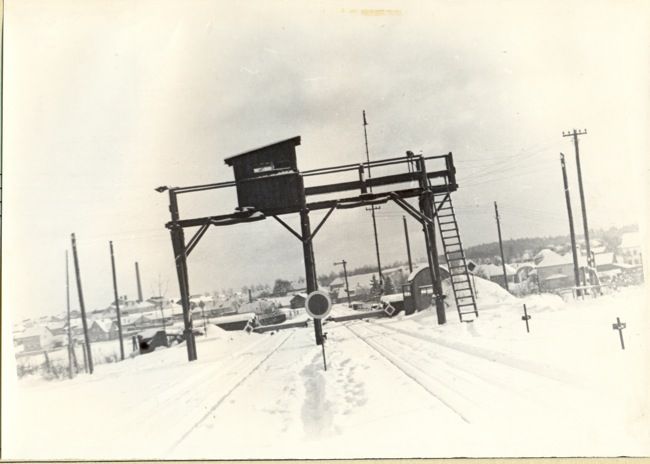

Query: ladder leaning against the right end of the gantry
[433,192,478,322]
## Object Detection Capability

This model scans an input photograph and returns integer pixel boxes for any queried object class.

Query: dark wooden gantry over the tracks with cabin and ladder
[156,136,470,361]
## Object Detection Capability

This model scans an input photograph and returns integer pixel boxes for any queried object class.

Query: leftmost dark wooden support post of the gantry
[169,189,196,361]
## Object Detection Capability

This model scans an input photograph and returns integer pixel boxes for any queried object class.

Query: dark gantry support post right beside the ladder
[417,158,447,324]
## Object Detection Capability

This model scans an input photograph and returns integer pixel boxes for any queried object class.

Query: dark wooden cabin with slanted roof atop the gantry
[224,136,305,213]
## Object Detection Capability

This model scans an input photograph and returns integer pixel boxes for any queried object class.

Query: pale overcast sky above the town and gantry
[2,0,650,320]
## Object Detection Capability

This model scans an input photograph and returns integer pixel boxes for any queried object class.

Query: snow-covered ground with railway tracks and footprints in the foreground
[3,279,650,459]
